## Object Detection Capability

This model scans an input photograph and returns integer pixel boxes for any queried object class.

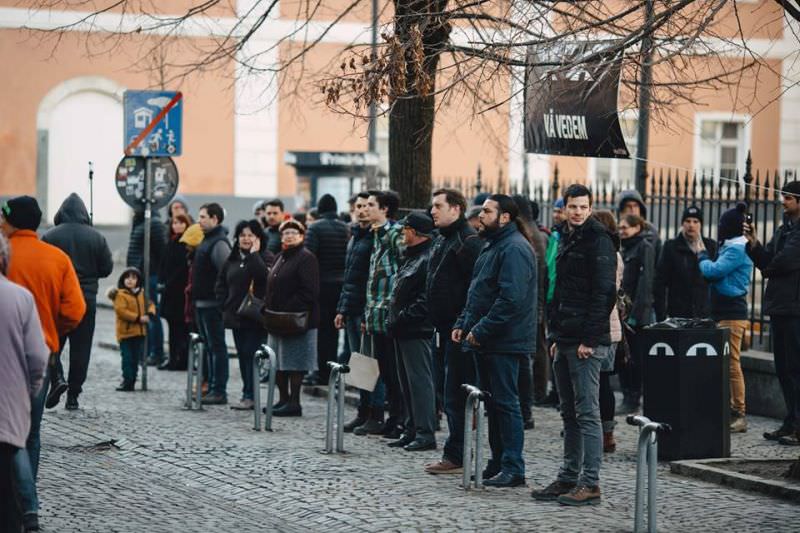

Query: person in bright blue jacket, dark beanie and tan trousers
[697,203,753,433]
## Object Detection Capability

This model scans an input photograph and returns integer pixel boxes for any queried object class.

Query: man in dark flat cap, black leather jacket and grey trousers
[386,211,436,452]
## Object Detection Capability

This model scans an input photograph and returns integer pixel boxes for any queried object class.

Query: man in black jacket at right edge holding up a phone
[743,181,800,445]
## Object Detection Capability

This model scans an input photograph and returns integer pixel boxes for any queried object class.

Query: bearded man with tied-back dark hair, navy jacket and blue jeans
[451,194,538,487]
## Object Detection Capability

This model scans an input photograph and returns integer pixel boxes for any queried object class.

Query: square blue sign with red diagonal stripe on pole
[123,91,183,157]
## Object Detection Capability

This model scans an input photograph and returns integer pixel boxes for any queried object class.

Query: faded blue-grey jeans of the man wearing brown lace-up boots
[553,344,611,487]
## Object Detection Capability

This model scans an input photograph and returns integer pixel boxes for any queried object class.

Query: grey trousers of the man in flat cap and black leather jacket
[394,339,436,441]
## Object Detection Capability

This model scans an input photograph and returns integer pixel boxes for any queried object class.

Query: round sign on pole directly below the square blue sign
[114,156,178,209]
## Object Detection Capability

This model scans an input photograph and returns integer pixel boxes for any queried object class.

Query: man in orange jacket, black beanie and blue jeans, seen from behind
[0,196,86,526]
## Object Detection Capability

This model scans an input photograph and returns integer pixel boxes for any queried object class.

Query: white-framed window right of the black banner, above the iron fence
[697,118,747,179]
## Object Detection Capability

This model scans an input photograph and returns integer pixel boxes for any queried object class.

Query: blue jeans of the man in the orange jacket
[14,366,51,514]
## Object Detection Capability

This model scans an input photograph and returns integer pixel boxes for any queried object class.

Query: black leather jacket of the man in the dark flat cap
[386,240,433,339]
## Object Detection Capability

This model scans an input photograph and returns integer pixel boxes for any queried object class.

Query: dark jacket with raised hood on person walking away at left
[42,193,114,302]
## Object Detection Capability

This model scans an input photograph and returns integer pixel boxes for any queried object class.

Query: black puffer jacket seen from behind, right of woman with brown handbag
[305,212,350,284]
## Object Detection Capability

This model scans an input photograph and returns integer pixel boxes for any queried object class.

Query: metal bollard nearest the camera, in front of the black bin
[627,415,672,533]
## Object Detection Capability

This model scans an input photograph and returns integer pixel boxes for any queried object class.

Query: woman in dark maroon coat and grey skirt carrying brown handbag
[266,220,319,416]
